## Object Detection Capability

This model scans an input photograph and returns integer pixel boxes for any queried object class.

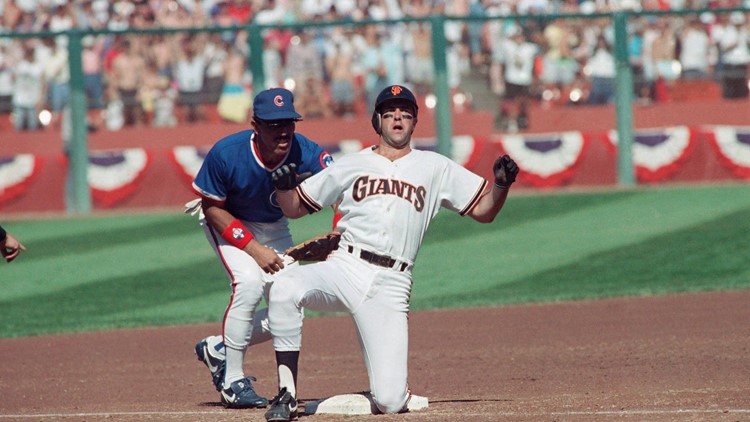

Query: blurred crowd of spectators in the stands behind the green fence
[0,0,750,130]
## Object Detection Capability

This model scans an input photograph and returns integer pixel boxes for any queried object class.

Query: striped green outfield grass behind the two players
[0,184,750,337]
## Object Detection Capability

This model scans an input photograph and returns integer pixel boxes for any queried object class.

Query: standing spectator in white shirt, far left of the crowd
[12,40,47,131]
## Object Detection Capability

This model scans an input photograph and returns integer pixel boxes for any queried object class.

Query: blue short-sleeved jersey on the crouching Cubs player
[193,130,333,223]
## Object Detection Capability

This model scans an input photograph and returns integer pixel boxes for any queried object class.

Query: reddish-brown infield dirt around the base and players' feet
[0,290,750,422]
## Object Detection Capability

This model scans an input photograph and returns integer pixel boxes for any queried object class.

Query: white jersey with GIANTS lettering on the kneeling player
[297,148,487,262]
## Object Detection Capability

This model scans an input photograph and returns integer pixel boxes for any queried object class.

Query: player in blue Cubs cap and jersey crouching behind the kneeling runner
[192,88,332,408]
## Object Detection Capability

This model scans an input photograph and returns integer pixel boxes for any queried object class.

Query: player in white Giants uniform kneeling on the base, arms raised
[265,85,518,421]
